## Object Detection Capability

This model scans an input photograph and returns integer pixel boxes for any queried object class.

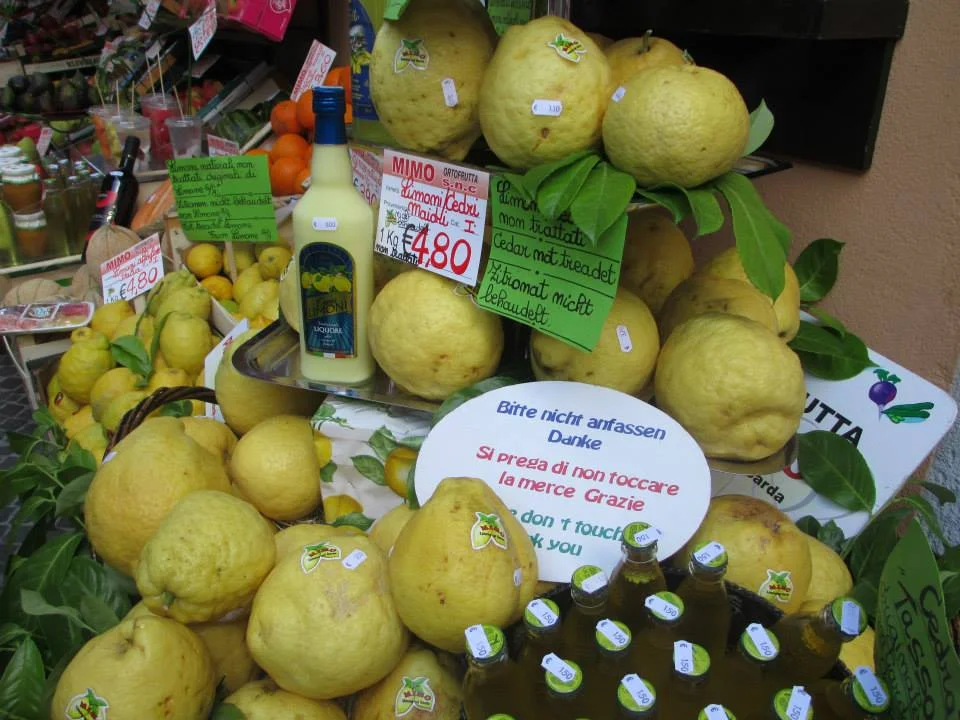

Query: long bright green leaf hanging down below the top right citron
[714,172,787,300]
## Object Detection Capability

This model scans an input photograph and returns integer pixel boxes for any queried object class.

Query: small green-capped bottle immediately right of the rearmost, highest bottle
[677,540,730,658]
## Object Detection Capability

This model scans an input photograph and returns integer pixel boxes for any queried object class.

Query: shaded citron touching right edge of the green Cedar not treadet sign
[620,205,693,315]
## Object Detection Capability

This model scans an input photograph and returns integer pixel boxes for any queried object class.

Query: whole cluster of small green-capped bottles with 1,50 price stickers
[464,523,889,720]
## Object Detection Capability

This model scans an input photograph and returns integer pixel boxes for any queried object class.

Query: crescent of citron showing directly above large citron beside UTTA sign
[657,274,777,340]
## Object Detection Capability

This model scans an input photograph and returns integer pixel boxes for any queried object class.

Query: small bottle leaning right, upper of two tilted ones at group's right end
[773,597,867,687]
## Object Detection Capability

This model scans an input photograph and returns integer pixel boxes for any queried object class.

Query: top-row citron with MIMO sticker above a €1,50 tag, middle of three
[480,15,611,169]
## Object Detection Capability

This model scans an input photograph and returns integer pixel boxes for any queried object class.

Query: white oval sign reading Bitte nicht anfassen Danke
[416,382,710,582]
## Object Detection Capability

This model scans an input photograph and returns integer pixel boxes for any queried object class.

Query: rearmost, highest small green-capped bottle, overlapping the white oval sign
[610,522,667,635]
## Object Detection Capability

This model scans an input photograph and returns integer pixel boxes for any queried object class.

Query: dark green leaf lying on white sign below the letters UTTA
[797,430,877,513]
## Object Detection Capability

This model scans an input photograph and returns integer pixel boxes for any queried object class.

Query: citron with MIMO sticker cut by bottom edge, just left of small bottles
[350,647,463,720]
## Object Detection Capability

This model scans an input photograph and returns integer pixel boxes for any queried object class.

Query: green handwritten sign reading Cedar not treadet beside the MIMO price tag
[477,175,627,351]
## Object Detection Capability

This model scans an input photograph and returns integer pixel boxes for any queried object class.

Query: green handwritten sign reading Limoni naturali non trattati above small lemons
[168,155,277,242]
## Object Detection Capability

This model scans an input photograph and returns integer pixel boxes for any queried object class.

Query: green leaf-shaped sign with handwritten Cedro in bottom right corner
[874,520,960,720]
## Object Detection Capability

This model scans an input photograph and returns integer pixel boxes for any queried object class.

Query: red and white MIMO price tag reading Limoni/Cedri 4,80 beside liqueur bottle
[374,149,490,287]
